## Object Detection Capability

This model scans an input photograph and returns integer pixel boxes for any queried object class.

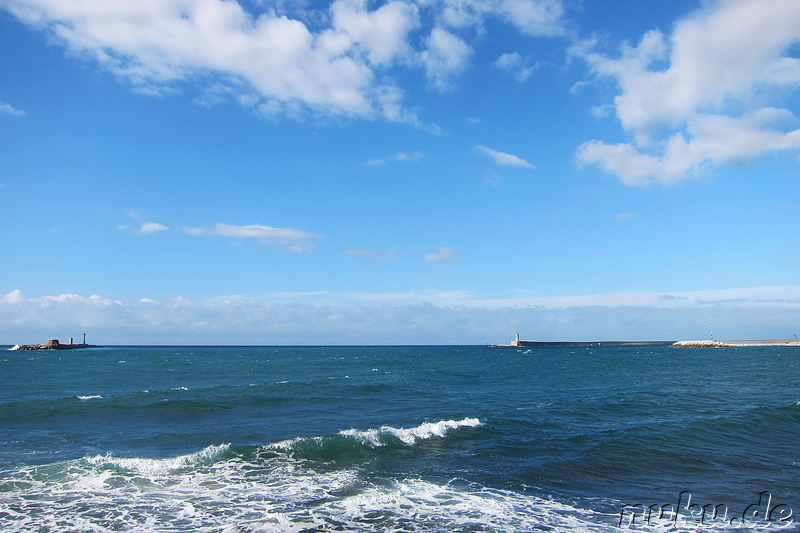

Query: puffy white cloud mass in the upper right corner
[576,0,800,185]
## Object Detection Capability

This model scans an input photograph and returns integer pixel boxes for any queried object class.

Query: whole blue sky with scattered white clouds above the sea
[0,0,800,345]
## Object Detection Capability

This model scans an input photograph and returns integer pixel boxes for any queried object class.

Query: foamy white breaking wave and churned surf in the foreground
[0,418,618,533]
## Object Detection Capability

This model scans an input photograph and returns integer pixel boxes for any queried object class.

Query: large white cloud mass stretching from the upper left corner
[5,0,418,120]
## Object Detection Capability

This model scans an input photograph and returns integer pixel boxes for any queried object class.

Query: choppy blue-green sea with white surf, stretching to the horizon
[0,346,800,533]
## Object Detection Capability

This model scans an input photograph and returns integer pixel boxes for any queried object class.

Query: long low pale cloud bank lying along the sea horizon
[0,286,800,344]
